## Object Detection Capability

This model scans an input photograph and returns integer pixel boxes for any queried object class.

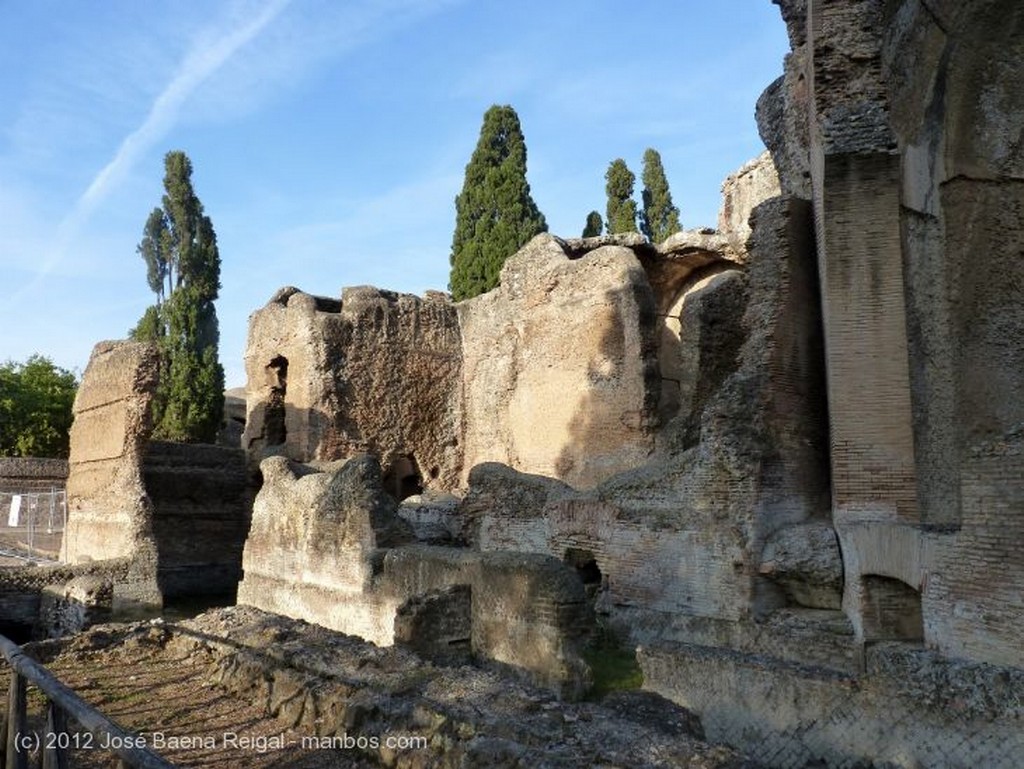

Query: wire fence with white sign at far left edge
[0,488,68,560]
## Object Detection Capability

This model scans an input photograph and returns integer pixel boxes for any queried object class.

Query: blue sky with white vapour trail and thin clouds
[0,0,787,386]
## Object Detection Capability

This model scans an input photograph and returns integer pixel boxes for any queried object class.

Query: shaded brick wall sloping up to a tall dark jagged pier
[463,200,838,639]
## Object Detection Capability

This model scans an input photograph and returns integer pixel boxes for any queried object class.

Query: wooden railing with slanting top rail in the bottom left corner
[0,636,175,769]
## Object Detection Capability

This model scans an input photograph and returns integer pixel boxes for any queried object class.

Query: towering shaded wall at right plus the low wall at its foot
[634,0,1024,768]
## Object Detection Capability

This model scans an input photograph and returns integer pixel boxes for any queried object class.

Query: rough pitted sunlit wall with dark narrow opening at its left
[243,287,462,496]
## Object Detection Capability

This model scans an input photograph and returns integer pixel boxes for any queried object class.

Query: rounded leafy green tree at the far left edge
[0,355,78,457]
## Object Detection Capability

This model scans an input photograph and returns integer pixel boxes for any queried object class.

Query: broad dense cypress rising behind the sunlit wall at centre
[449,104,548,301]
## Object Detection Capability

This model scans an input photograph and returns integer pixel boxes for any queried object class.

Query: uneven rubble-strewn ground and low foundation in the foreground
[29,606,757,769]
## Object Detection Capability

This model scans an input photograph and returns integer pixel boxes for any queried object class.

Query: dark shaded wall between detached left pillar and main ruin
[142,441,250,598]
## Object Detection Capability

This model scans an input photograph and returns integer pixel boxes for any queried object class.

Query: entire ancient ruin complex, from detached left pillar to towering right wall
[36,0,1024,768]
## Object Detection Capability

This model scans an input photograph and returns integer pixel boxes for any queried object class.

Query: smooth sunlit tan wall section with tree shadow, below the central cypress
[458,234,657,486]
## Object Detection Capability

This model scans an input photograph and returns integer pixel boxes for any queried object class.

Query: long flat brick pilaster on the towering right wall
[816,155,919,520]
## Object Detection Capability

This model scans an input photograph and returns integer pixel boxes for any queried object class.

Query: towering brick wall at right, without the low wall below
[759,0,1024,665]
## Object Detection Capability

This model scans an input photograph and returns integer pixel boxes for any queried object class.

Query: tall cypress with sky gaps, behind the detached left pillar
[130,152,224,442]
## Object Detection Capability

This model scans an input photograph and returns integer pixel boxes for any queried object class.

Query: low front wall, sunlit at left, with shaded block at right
[239,455,590,697]
